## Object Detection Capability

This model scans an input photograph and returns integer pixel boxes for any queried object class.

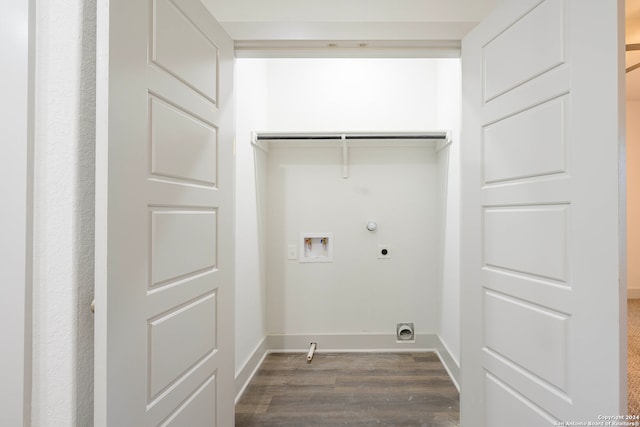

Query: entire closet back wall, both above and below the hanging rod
[267,59,439,340]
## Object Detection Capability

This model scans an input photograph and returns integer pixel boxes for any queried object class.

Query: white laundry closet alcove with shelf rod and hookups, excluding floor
[236,58,460,402]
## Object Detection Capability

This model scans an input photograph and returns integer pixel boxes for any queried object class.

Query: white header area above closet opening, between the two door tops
[204,0,500,40]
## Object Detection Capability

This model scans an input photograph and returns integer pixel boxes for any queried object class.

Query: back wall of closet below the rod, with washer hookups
[267,147,439,336]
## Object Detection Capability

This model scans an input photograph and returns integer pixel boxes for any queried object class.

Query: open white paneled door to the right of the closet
[461,0,626,427]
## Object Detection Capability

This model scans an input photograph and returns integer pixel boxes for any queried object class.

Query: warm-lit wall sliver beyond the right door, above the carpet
[627,101,640,298]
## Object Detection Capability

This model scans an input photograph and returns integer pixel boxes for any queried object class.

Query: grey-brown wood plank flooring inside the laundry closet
[236,353,460,427]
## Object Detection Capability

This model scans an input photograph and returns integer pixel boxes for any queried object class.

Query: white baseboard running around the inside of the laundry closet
[235,334,460,403]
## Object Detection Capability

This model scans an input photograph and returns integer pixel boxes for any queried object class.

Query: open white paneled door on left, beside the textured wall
[95,0,234,427]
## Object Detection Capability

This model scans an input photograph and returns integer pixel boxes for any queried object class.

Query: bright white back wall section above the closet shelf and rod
[268,59,437,131]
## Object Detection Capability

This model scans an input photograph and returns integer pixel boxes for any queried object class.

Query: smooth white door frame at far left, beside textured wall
[0,0,35,426]
